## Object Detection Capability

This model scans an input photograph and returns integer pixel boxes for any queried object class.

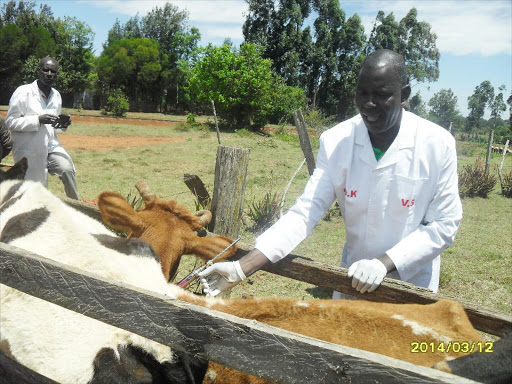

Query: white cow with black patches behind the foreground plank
[0,158,208,384]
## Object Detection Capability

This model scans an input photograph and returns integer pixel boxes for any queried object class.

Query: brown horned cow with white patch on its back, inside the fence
[98,182,482,383]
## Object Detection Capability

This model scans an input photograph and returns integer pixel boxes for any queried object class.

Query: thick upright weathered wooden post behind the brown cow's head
[208,145,250,238]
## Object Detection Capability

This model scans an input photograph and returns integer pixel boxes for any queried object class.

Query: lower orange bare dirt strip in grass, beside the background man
[59,135,185,151]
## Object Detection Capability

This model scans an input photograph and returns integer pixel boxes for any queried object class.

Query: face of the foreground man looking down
[355,65,408,134]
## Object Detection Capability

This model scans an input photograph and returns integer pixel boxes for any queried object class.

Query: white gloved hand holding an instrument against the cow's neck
[198,261,246,296]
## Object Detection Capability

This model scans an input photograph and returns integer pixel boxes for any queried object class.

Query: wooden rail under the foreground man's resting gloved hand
[235,242,512,336]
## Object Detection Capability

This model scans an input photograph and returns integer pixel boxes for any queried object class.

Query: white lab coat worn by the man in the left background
[5,81,71,187]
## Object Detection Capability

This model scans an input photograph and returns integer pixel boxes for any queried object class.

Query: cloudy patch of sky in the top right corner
[352,0,512,56]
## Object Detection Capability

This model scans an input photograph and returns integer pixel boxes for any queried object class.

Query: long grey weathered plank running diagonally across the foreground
[0,243,472,384]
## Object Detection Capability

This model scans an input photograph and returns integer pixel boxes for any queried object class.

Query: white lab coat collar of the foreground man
[355,110,416,169]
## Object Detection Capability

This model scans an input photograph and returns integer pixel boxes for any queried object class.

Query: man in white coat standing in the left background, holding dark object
[5,57,79,200]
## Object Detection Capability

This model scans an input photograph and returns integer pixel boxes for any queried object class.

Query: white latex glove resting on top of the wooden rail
[347,259,388,293]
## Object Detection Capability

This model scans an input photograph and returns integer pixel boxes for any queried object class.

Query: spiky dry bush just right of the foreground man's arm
[459,158,497,197]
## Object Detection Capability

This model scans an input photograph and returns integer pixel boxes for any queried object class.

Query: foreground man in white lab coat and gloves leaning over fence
[200,50,462,298]
